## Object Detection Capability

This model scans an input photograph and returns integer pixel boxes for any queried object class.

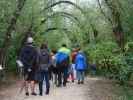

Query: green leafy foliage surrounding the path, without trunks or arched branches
[0,0,133,85]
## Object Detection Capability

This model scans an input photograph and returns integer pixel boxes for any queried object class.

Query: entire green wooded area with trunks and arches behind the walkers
[0,0,133,83]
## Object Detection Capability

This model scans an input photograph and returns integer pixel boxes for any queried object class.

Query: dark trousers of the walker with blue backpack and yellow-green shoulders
[57,66,68,86]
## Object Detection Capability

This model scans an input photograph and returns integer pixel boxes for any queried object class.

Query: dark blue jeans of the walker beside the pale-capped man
[39,70,50,94]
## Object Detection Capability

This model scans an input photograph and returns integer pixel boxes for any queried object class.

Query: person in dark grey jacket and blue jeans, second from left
[39,44,50,96]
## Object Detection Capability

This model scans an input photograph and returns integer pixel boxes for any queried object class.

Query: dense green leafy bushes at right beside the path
[86,42,133,83]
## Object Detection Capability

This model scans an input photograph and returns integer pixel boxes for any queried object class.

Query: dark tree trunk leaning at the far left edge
[0,0,26,67]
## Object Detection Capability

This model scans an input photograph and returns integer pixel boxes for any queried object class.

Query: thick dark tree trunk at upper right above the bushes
[105,0,125,50]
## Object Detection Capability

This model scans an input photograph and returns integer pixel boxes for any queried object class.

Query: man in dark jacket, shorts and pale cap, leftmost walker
[20,37,37,96]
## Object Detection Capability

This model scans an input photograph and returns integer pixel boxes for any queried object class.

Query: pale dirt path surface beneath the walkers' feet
[0,77,115,100]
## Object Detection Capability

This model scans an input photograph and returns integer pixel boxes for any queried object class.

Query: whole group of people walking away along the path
[19,37,87,96]
